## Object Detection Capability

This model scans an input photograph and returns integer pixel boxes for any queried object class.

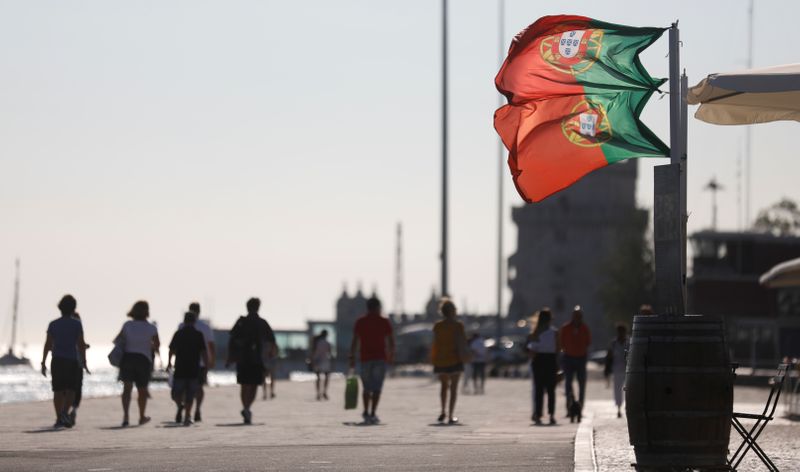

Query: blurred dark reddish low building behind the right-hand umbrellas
[687,231,800,367]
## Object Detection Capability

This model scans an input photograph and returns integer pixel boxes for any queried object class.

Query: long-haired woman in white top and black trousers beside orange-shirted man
[526,307,561,425]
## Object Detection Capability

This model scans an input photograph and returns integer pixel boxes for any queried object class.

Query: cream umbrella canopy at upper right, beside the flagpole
[686,64,800,125]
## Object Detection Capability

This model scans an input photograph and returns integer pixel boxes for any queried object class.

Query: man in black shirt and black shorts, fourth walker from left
[225,297,275,424]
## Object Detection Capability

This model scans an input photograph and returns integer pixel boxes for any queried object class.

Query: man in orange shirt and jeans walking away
[559,305,592,412]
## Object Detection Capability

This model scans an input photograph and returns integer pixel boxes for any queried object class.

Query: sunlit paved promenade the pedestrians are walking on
[0,378,577,472]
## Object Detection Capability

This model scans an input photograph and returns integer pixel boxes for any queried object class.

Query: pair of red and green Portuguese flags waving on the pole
[494,15,669,202]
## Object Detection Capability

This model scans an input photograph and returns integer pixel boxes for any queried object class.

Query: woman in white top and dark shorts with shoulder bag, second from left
[114,300,161,427]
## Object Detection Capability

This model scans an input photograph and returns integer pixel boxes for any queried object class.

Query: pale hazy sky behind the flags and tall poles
[0,0,800,345]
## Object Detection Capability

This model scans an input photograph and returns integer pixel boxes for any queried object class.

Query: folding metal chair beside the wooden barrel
[728,364,788,472]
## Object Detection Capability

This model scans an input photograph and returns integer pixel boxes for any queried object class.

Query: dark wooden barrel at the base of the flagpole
[625,315,734,470]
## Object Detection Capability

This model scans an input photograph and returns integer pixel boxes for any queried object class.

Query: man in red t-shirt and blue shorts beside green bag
[350,297,394,424]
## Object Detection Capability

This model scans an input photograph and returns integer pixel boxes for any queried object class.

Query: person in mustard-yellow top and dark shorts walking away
[431,298,470,424]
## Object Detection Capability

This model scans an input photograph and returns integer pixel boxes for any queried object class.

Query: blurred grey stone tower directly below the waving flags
[508,161,647,347]
